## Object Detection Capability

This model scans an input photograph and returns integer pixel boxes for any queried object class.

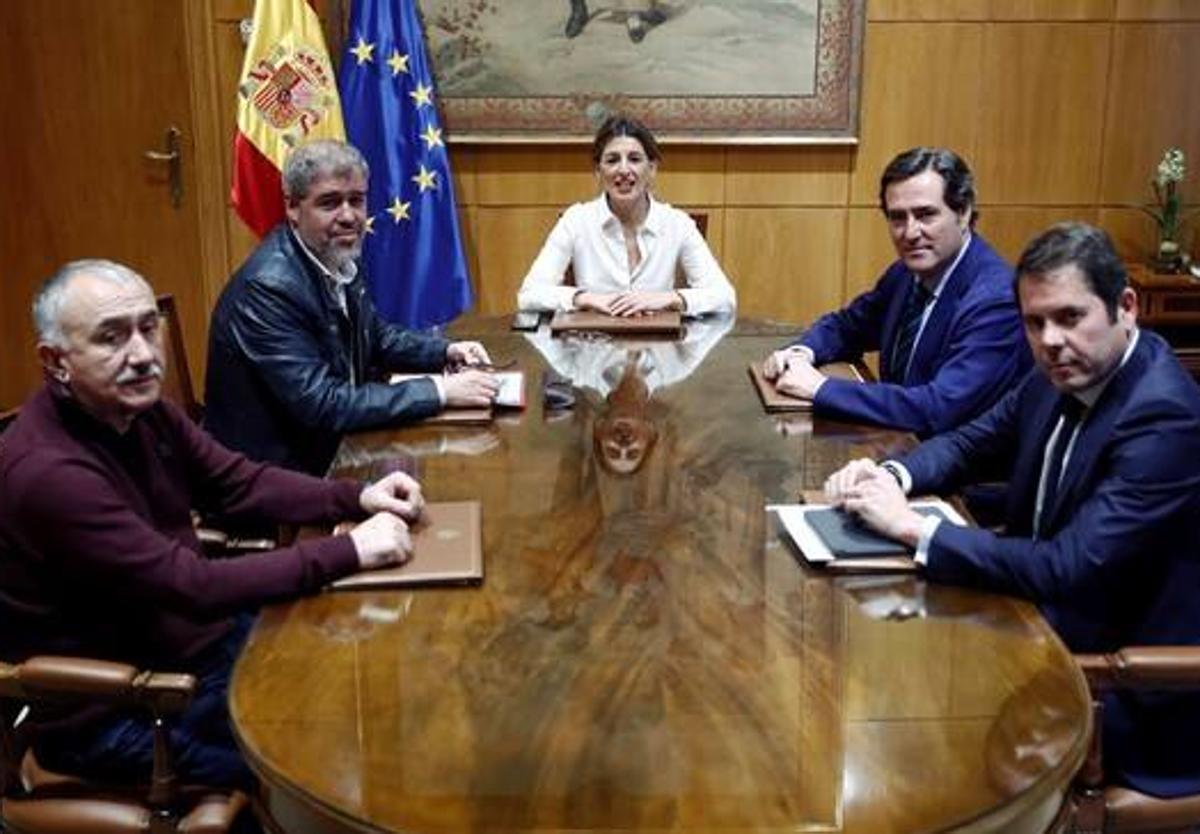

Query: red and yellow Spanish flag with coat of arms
[232,0,346,238]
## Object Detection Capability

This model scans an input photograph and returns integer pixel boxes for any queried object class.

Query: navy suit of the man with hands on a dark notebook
[901,330,1200,796]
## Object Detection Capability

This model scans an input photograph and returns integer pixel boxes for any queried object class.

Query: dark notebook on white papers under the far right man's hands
[773,498,966,572]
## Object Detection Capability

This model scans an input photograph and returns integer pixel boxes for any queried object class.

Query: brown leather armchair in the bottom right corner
[1069,646,1200,834]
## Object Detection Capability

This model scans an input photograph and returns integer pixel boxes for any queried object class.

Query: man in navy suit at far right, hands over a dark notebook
[826,223,1200,796]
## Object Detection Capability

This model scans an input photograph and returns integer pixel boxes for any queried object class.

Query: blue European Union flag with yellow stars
[338,0,472,328]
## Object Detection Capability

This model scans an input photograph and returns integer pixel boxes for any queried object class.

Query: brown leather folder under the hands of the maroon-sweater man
[330,500,484,590]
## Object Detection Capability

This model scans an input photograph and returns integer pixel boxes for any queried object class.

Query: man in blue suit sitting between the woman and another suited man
[764,148,1030,436]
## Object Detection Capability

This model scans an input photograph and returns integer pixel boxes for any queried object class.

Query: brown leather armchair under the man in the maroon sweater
[0,656,248,834]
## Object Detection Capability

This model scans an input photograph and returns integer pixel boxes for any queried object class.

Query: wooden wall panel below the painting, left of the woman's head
[475,145,598,211]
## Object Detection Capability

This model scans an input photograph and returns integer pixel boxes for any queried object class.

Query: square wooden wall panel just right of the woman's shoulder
[722,208,846,323]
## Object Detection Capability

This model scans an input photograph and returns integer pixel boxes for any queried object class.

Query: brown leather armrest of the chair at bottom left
[0,655,196,715]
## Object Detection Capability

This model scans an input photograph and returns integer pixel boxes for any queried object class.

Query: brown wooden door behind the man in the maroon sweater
[0,0,208,408]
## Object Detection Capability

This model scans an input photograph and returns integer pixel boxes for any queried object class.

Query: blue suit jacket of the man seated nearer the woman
[797,234,1031,436]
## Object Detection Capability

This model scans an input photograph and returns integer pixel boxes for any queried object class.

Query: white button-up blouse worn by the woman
[517,194,737,316]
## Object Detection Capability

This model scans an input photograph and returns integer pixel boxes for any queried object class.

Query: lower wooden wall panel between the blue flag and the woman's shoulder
[475,205,559,314]
